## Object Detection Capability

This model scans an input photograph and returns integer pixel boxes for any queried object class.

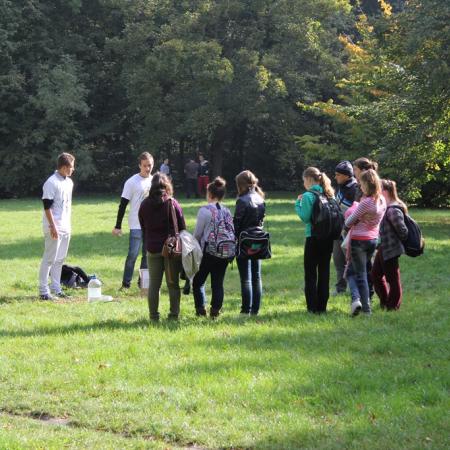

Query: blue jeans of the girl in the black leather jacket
[236,258,262,314]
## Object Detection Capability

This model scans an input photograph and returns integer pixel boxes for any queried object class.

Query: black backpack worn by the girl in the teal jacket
[308,191,344,239]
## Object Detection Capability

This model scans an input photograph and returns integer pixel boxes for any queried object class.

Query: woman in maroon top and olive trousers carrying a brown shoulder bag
[139,172,186,322]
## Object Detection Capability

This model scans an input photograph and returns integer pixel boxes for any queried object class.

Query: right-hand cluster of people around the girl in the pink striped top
[295,158,408,316]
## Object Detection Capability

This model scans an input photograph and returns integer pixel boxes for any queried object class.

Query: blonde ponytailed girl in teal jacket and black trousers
[295,167,334,314]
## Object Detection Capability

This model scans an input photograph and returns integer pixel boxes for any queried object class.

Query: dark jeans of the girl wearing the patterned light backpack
[192,252,228,313]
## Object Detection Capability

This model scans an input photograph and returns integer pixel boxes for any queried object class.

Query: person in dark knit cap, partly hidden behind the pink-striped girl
[333,161,358,295]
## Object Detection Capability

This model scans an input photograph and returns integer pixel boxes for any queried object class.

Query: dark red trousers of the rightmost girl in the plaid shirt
[372,247,402,309]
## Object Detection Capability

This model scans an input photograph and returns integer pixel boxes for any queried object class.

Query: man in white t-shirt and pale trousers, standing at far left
[39,153,75,300]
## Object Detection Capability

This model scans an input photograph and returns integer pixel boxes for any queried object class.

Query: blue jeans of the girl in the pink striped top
[349,239,377,313]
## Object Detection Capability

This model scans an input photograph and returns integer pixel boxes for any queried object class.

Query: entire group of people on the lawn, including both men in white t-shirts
[39,152,408,321]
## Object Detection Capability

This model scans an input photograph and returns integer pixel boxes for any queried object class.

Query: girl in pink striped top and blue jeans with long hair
[345,169,386,316]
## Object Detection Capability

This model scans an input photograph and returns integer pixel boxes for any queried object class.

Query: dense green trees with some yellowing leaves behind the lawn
[0,0,450,207]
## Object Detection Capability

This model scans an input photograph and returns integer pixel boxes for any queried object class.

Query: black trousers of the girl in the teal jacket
[303,237,333,313]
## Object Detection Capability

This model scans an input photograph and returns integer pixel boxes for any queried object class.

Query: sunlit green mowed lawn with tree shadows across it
[0,194,450,449]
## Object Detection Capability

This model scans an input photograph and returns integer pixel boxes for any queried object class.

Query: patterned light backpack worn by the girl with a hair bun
[205,205,236,261]
